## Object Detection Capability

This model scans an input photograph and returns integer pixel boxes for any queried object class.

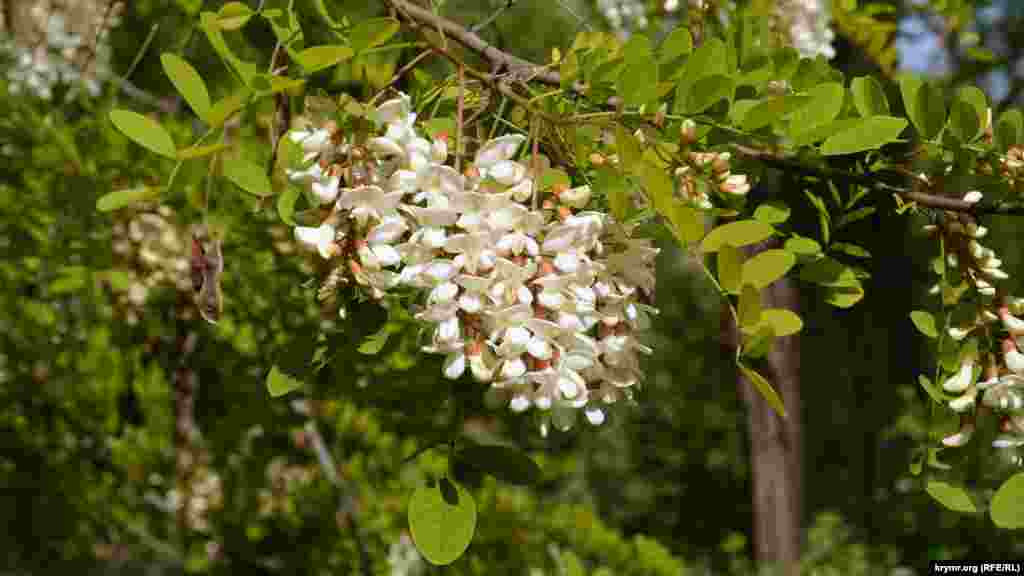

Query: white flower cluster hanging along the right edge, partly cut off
[926,191,1024,448]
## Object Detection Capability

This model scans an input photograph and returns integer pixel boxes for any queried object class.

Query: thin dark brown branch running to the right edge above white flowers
[732,143,1024,216]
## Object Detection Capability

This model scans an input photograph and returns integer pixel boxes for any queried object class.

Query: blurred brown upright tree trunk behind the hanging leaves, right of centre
[722,241,803,575]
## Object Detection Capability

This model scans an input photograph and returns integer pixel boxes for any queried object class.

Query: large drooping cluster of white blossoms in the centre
[289,95,657,427]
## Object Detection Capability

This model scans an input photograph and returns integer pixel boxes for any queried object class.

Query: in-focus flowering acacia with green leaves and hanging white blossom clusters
[100,0,1024,564]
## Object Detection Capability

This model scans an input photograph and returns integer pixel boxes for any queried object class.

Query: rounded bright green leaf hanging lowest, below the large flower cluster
[409,479,476,566]
